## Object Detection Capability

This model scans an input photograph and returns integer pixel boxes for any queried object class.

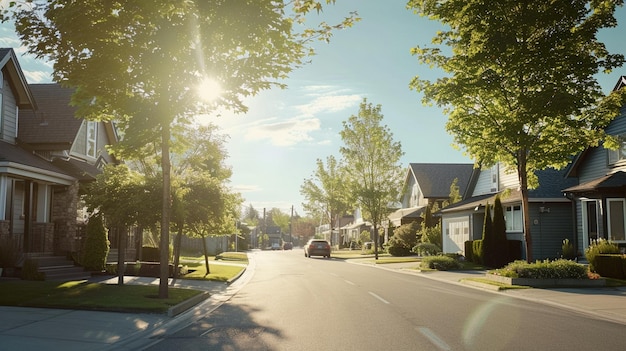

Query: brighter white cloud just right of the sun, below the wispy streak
[246,118,320,146]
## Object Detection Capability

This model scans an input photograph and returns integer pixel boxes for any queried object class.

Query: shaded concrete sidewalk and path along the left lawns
[0,265,253,351]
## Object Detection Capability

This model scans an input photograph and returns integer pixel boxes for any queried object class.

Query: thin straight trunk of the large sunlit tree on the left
[159,121,171,299]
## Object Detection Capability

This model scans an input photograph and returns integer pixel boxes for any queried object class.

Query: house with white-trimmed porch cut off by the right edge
[563,76,626,253]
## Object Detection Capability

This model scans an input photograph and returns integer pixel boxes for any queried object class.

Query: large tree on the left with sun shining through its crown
[1,0,357,298]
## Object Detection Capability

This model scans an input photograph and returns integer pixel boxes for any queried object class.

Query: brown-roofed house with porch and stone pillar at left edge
[0,49,117,264]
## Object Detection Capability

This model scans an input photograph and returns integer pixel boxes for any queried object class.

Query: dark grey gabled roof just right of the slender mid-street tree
[406,163,474,199]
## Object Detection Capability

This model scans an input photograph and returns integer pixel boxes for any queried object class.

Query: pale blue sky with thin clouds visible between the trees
[0,0,626,214]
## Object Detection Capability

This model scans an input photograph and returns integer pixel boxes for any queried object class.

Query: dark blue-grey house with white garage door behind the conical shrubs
[440,164,576,259]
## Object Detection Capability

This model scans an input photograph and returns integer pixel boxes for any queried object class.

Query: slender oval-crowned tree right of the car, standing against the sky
[340,99,404,259]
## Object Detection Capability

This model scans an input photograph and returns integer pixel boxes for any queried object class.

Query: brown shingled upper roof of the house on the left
[18,84,82,150]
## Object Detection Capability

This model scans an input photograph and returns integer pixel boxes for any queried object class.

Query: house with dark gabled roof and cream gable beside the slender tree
[387,163,478,227]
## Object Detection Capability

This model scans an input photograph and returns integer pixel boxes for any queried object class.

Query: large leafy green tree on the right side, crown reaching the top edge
[408,0,624,261]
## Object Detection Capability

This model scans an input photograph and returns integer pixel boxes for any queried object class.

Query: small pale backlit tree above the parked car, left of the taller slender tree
[300,155,351,245]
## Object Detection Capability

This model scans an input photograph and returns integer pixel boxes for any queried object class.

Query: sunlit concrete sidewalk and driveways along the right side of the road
[360,262,626,325]
